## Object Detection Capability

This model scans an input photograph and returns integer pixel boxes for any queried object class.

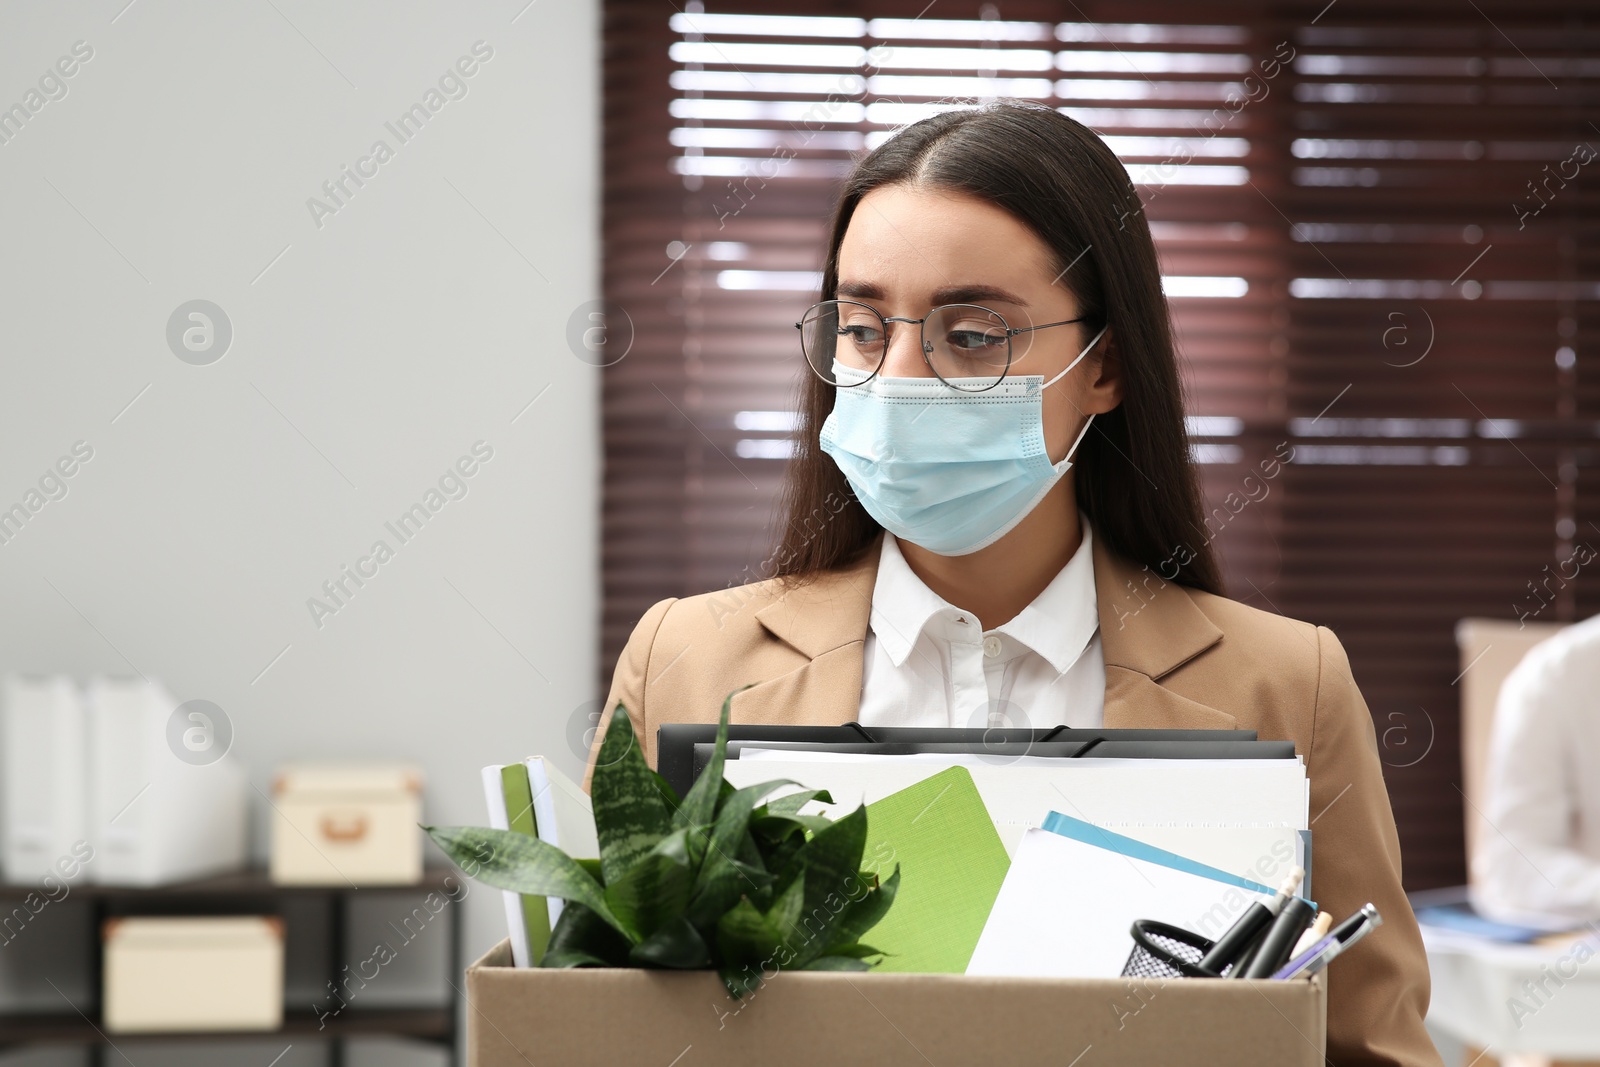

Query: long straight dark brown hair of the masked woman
[770,101,1222,593]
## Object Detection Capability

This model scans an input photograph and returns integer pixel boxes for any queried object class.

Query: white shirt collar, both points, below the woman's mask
[870,512,1099,673]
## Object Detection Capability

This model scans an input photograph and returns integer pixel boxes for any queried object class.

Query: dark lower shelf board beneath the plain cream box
[0,1008,454,1048]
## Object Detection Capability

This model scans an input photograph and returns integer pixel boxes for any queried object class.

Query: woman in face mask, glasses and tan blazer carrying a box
[586,104,1438,1065]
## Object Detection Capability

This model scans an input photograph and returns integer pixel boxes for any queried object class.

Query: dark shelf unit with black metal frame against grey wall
[0,867,462,1067]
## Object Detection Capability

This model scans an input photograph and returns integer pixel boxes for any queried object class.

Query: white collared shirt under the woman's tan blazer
[859,514,1106,728]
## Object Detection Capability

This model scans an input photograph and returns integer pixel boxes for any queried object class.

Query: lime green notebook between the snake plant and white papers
[861,766,1011,974]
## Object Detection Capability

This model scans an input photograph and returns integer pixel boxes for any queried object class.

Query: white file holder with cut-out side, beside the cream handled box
[88,677,248,886]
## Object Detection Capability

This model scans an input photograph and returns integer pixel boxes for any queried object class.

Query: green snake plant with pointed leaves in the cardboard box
[422,694,899,998]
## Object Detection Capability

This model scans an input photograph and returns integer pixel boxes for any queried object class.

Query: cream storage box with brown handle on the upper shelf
[272,763,422,888]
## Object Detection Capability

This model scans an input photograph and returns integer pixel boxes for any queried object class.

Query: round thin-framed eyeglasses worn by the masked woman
[795,301,1088,392]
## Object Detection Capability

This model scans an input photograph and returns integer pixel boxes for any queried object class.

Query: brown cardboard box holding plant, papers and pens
[466,941,1328,1067]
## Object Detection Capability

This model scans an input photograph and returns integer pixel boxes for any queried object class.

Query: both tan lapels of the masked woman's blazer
[733,537,1237,729]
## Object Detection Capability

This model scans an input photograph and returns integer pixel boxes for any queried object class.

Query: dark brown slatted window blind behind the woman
[597,0,1600,888]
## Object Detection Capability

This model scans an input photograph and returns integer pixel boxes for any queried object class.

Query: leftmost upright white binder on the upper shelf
[0,673,93,883]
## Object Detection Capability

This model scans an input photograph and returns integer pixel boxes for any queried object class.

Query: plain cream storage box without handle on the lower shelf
[102,915,283,1033]
